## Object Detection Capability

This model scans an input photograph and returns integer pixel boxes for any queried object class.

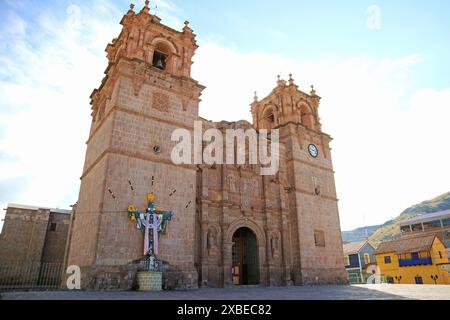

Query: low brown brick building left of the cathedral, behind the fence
[0,205,70,286]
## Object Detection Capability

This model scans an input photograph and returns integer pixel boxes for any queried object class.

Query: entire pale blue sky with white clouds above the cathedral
[0,0,450,230]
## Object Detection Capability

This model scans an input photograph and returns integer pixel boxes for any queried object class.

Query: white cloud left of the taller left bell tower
[0,2,120,229]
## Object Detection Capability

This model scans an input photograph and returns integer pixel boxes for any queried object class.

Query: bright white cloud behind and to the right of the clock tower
[193,44,450,229]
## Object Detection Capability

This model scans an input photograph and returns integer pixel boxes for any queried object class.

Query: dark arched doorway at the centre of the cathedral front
[232,228,259,285]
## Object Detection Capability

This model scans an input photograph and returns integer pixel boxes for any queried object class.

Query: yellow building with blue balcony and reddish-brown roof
[375,235,450,284]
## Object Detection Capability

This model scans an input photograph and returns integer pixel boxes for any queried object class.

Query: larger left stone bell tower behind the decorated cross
[68,1,205,289]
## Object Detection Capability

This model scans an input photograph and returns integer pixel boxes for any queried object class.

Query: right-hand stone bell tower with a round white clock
[251,75,347,284]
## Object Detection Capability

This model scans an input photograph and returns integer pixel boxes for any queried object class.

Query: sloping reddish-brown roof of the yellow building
[375,235,436,254]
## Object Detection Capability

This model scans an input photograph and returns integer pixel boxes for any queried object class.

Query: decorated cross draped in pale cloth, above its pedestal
[128,193,173,256]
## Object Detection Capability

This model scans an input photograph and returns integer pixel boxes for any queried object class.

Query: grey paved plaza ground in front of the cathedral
[0,285,450,300]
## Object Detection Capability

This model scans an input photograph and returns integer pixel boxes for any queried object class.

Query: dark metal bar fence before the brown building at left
[0,261,64,291]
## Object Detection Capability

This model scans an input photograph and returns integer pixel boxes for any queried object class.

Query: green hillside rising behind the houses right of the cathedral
[342,192,450,246]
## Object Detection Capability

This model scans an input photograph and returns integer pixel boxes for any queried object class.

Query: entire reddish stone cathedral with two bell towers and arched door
[67,4,347,288]
